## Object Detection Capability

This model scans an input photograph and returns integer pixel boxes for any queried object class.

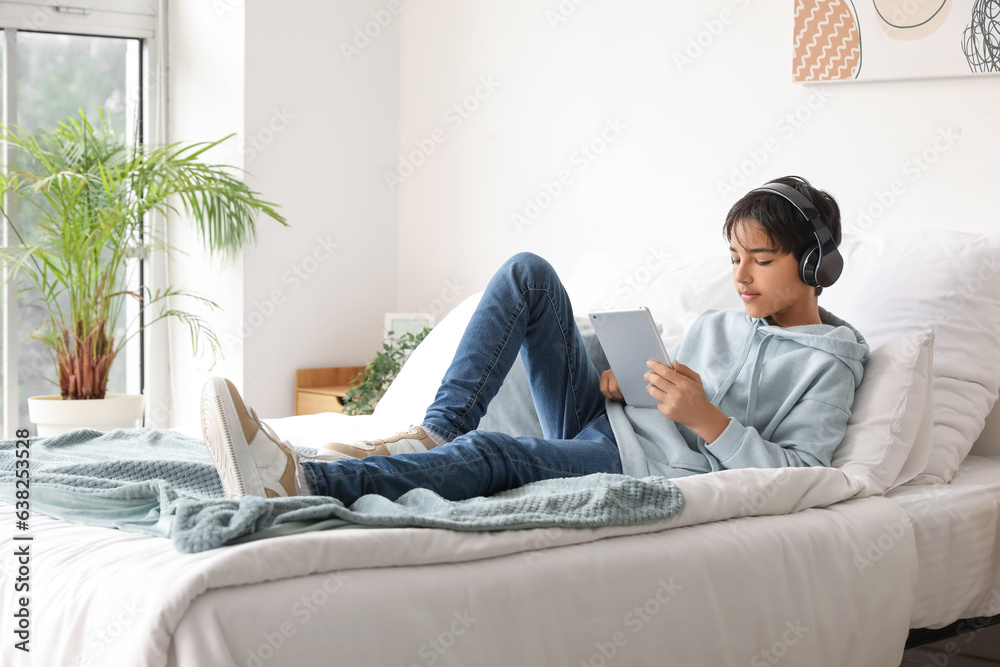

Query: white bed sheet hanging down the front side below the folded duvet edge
[168,498,912,667]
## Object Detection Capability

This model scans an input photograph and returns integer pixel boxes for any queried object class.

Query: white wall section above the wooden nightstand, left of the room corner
[243,0,400,417]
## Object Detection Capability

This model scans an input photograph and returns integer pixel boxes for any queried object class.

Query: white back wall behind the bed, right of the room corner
[398,0,1000,318]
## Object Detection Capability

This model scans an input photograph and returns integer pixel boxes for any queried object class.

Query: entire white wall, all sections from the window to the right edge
[171,0,1000,430]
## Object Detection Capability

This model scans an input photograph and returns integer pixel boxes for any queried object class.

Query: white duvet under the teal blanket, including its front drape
[0,468,916,667]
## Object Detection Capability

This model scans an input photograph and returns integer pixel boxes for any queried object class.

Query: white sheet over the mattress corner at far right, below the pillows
[886,455,1000,628]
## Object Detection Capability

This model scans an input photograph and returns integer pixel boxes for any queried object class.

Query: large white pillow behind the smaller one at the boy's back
[820,229,1000,483]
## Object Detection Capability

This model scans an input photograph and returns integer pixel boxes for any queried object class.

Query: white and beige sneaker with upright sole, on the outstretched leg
[201,377,302,498]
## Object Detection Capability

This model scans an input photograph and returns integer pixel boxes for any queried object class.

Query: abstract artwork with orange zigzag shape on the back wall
[792,0,1000,83]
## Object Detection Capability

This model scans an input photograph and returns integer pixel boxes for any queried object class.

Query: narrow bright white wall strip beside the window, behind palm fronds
[166,0,244,435]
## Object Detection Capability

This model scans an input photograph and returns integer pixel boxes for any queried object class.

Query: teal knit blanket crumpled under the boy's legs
[0,428,684,553]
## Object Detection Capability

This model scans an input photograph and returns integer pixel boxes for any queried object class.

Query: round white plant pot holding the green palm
[28,393,142,438]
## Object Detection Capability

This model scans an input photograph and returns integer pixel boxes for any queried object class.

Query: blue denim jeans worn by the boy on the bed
[303,253,622,505]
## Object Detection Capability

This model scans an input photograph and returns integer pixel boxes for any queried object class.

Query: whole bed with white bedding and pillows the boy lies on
[0,231,1000,667]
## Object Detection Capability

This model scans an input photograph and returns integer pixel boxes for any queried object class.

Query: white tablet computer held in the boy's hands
[590,306,672,407]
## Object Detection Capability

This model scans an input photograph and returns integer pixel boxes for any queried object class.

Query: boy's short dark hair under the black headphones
[722,176,841,295]
